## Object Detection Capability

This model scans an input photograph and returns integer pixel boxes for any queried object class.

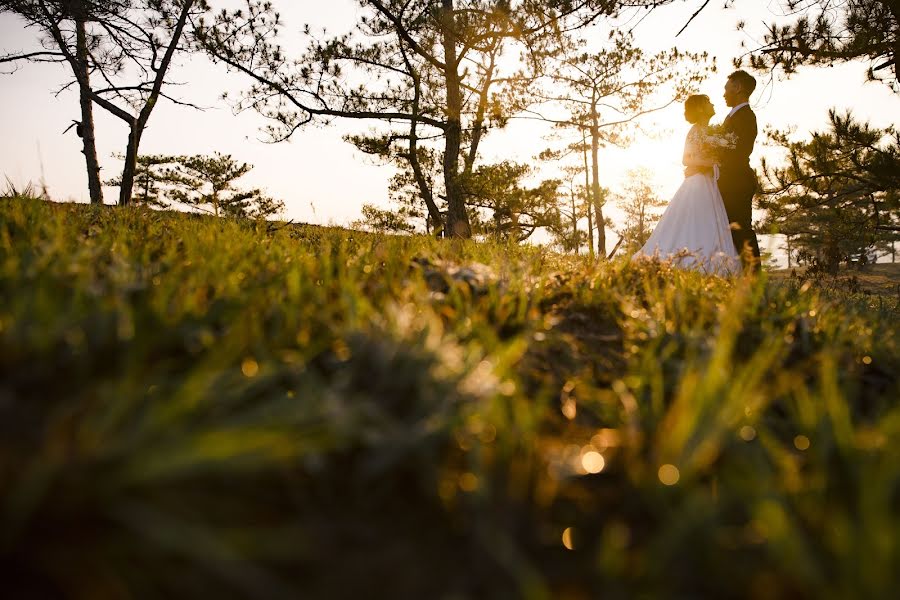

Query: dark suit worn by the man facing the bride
[718,106,759,258]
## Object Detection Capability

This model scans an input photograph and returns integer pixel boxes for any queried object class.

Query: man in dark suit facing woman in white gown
[718,71,760,271]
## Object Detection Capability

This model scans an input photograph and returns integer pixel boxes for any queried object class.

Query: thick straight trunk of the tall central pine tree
[441,0,472,238]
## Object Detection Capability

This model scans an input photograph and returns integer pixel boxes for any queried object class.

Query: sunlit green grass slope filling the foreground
[0,199,900,599]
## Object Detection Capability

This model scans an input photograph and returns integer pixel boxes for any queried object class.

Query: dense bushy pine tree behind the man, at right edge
[759,110,900,271]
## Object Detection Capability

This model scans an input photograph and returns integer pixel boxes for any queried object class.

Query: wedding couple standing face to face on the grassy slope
[633,71,759,274]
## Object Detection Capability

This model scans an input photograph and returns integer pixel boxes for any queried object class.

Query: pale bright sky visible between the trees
[0,0,900,262]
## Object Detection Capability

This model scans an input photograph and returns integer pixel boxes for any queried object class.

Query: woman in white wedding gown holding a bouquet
[632,95,741,275]
